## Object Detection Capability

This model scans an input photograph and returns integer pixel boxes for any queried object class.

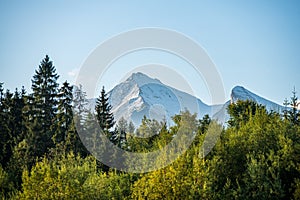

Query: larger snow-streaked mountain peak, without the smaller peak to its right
[108,72,213,125]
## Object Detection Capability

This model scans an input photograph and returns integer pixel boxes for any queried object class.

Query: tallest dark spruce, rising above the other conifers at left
[30,55,59,157]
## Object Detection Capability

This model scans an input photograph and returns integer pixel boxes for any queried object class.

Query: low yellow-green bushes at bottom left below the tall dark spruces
[19,154,130,199]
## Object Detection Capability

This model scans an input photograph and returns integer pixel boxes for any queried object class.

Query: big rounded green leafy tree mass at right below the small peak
[208,102,300,199]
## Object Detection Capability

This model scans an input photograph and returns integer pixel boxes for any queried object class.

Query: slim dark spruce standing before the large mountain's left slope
[95,87,115,136]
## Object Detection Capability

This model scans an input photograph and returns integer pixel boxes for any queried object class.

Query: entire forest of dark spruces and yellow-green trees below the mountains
[0,56,300,200]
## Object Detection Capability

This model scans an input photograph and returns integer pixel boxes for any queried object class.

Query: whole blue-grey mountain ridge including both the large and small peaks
[88,72,283,125]
